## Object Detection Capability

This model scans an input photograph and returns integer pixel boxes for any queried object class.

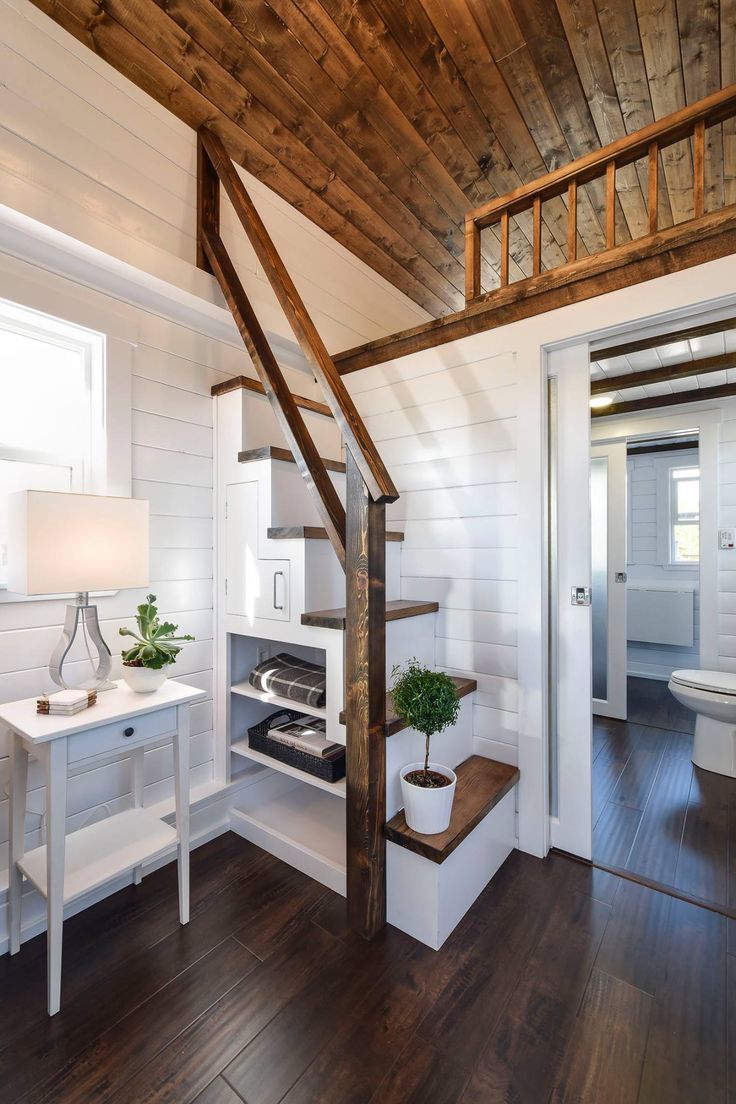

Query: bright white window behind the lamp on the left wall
[0,300,105,588]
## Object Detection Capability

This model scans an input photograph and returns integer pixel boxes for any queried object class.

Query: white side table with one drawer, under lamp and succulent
[0,681,205,1016]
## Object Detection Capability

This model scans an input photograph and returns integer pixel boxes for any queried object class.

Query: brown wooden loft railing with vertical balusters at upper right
[466,84,736,305]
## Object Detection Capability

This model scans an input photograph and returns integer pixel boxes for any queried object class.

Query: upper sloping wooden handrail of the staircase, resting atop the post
[199,126,398,503]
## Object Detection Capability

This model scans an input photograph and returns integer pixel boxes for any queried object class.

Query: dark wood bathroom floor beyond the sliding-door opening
[593,678,736,915]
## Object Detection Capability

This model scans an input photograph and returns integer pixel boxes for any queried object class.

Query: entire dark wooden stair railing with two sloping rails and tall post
[196,127,390,938]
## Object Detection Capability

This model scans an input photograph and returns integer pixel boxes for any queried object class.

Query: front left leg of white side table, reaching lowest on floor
[46,740,66,1016]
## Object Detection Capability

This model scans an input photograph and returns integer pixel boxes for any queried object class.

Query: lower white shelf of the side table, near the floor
[19,809,178,903]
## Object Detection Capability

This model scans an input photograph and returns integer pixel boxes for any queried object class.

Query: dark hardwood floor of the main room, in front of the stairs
[0,825,736,1104]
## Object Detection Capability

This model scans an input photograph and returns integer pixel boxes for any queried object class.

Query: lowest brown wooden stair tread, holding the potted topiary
[384,755,519,862]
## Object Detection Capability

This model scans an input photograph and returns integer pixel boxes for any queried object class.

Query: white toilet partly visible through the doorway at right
[669,671,736,778]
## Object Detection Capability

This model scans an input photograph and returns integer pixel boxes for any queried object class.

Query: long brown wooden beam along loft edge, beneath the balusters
[332,208,736,373]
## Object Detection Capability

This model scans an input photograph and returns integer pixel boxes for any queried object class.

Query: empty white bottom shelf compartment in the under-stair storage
[230,782,345,895]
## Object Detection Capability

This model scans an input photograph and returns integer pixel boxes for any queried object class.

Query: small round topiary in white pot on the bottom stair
[391,659,460,836]
